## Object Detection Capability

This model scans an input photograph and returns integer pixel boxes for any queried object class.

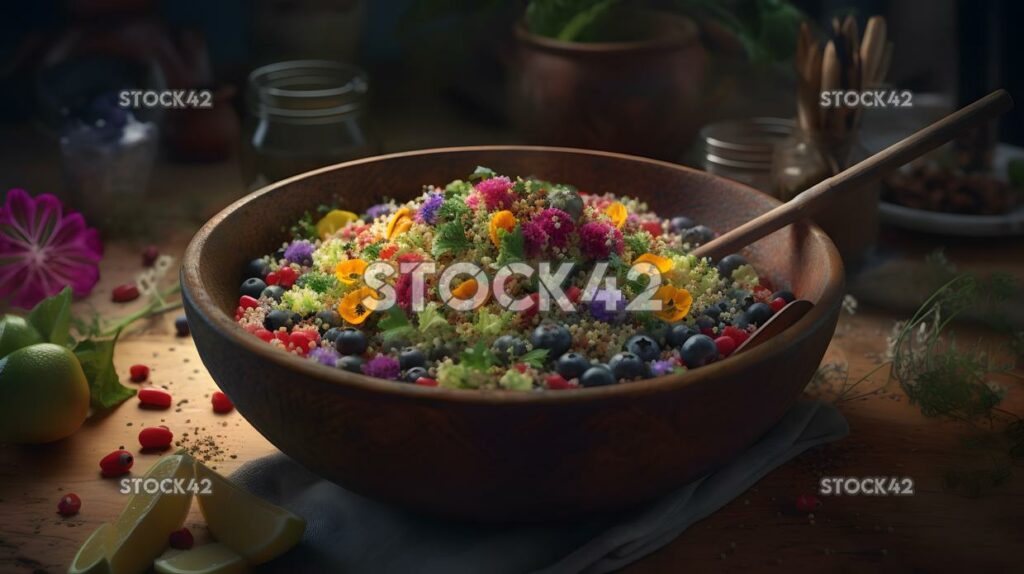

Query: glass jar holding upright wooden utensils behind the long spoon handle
[773,130,881,270]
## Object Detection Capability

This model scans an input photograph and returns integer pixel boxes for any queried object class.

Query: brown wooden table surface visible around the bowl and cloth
[0,142,1024,573]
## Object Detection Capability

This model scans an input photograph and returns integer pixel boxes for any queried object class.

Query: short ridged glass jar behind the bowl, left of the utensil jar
[700,118,796,194]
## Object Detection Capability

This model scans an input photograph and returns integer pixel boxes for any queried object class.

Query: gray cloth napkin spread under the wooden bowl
[232,402,849,574]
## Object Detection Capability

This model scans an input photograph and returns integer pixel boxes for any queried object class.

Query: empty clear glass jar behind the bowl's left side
[243,60,378,188]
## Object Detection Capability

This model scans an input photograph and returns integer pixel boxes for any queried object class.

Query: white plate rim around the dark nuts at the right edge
[879,143,1024,237]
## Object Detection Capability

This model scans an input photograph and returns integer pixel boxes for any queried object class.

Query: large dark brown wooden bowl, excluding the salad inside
[181,146,843,522]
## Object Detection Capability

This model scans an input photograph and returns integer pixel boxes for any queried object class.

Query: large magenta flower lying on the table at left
[0,189,103,309]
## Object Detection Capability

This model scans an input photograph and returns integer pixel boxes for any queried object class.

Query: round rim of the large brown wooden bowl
[179,145,845,405]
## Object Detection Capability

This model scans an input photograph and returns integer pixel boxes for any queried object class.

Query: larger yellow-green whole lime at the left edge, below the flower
[0,343,89,444]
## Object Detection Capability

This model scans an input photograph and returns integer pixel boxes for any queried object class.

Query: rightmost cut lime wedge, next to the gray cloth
[196,461,306,564]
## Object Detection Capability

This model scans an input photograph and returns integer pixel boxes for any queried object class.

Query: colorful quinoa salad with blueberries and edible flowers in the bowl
[234,168,794,391]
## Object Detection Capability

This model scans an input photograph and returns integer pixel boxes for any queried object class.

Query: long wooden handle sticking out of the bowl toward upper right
[693,89,1014,259]
